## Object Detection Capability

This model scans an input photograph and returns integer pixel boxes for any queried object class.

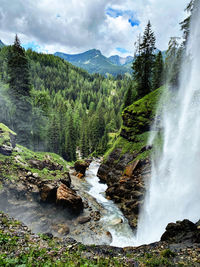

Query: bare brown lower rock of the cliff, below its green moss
[97,149,151,228]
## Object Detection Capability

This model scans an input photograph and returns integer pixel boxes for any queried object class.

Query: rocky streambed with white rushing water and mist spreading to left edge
[0,160,134,247]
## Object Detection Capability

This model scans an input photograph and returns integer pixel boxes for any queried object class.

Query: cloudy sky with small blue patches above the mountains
[0,0,189,56]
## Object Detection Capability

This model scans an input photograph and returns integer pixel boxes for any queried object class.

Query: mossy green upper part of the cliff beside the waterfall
[105,87,163,160]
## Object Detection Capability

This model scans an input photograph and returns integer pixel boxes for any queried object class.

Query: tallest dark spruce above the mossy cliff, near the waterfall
[132,21,156,98]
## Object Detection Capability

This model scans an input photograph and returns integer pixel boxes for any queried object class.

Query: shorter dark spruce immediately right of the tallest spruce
[152,51,164,90]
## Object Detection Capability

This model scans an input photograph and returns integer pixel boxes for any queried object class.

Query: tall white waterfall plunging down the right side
[136,1,200,245]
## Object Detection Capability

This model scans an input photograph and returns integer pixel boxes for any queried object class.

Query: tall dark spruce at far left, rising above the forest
[8,35,32,147]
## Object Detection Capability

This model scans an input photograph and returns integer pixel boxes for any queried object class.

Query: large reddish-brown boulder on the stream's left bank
[56,184,83,213]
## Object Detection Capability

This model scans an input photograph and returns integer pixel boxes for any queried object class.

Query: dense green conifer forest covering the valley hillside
[0,36,129,161]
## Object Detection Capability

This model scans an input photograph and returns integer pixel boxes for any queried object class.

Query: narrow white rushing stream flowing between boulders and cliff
[85,161,134,247]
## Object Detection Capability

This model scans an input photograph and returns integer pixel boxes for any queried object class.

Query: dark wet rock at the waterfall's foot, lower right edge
[161,220,200,243]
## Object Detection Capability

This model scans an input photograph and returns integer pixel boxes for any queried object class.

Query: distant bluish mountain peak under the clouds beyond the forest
[54,49,132,76]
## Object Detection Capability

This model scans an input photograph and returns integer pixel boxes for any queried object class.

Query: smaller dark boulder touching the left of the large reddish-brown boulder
[40,183,57,203]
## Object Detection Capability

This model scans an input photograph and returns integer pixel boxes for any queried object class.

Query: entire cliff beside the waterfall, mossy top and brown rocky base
[98,88,162,228]
